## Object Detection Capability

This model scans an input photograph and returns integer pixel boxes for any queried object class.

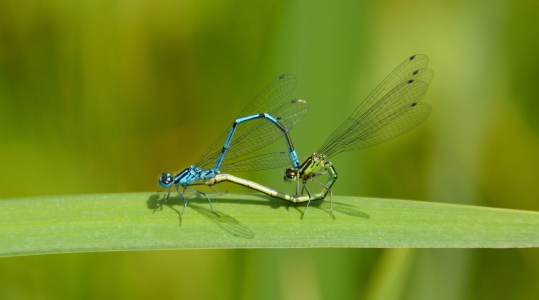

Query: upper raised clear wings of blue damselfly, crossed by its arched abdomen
[196,74,309,169]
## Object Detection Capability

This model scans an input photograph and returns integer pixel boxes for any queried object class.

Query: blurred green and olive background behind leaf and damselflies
[0,0,539,299]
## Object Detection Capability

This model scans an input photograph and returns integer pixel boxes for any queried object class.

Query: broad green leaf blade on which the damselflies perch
[0,193,539,256]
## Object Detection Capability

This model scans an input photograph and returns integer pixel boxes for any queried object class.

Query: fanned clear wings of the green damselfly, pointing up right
[318,55,434,157]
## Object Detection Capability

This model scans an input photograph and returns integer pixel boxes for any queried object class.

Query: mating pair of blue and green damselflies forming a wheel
[154,55,434,224]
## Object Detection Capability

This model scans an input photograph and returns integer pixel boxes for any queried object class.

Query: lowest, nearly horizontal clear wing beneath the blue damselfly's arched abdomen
[221,152,290,172]
